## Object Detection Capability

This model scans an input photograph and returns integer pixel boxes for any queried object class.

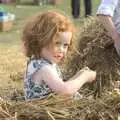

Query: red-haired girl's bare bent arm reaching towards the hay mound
[33,66,96,94]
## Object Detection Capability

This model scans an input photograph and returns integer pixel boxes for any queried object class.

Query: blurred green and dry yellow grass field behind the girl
[0,0,99,87]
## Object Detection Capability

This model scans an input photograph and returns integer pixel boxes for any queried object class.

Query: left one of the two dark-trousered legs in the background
[71,0,80,18]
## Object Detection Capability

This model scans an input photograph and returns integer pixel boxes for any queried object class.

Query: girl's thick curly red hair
[22,11,75,57]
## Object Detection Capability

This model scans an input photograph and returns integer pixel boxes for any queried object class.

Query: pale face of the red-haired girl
[41,32,72,63]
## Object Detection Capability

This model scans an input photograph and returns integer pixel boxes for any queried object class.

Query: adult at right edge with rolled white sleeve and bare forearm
[97,0,120,55]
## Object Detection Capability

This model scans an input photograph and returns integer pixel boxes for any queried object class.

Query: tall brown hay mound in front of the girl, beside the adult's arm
[65,17,120,92]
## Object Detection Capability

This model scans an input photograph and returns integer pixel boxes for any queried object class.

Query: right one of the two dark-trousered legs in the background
[84,0,92,17]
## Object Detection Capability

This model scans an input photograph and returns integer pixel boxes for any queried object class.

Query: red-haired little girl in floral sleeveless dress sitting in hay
[22,11,96,99]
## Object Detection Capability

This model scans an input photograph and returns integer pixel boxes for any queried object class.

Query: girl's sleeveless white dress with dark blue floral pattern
[24,58,61,99]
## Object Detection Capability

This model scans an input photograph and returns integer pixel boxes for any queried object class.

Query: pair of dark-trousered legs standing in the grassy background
[71,0,92,18]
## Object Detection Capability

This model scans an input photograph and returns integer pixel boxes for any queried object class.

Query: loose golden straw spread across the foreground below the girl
[0,93,120,120]
